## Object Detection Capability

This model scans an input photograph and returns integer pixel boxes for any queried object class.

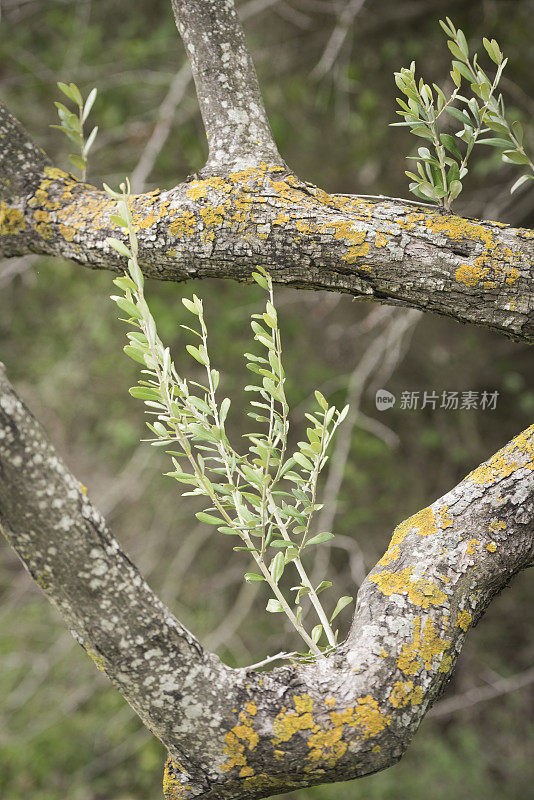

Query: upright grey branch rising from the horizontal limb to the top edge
[172,0,284,174]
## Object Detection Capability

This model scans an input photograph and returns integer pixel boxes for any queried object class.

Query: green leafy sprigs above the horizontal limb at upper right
[392,17,534,210]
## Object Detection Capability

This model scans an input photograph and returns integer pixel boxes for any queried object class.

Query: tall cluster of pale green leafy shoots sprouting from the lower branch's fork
[104,178,352,657]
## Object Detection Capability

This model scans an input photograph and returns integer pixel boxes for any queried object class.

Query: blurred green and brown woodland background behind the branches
[0,0,534,800]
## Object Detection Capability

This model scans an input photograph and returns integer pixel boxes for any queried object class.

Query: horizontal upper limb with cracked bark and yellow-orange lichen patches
[0,150,534,342]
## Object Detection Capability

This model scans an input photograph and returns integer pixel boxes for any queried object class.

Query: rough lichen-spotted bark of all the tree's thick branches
[0,0,534,800]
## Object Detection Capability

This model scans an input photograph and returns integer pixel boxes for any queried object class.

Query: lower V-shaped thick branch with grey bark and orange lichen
[0,364,534,800]
